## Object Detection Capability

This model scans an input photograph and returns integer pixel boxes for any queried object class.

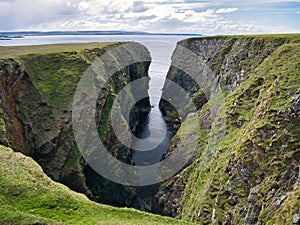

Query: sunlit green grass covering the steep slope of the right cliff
[173,34,300,224]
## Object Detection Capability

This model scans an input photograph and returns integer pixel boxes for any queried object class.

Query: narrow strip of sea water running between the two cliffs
[132,41,176,211]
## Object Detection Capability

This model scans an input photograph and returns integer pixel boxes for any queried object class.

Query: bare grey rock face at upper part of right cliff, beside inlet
[159,37,286,125]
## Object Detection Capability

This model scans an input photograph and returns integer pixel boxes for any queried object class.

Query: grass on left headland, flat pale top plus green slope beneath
[0,42,124,110]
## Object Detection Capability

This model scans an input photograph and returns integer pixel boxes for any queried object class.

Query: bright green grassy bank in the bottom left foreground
[0,146,195,225]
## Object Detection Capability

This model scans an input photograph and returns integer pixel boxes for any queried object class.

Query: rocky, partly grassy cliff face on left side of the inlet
[0,44,151,206]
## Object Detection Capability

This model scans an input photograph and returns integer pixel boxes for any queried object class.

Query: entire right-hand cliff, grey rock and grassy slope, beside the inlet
[153,35,300,224]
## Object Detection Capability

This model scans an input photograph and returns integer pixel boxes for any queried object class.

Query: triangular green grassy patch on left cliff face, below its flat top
[19,52,89,109]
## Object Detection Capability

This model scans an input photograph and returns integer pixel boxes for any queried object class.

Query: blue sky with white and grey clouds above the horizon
[0,0,300,35]
